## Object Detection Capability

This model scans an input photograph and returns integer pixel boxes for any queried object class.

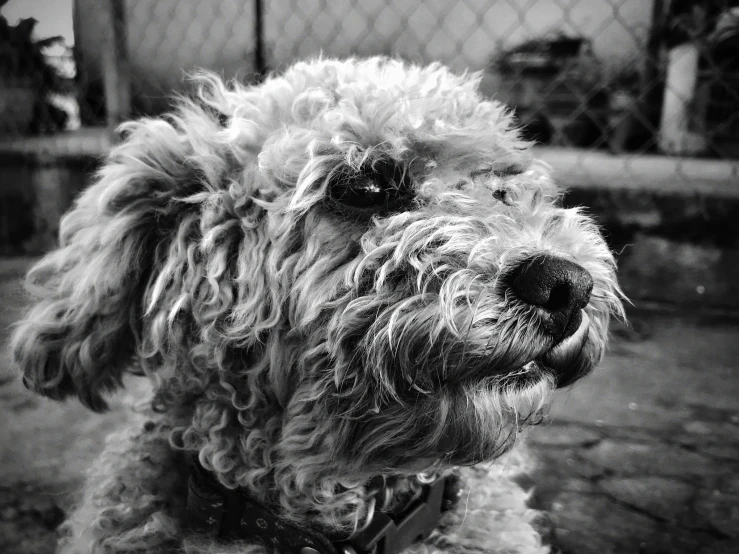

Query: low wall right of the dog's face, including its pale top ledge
[537,148,739,311]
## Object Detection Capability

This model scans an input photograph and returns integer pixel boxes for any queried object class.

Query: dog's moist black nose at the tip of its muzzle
[507,254,593,341]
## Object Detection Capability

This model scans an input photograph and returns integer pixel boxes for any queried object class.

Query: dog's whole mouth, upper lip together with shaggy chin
[328,302,602,470]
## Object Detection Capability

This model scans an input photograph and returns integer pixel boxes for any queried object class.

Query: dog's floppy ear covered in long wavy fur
[11,119,208,411]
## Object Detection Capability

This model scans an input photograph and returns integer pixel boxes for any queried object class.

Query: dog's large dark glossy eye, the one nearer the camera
[329,160,413,213]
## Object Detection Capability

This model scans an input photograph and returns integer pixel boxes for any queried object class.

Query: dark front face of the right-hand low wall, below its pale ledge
[565,187,739,310]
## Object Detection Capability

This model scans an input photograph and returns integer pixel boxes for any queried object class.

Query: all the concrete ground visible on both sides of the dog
[0,258,739,554]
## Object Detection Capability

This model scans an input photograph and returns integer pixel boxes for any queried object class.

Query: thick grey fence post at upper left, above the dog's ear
[103,0,131,131]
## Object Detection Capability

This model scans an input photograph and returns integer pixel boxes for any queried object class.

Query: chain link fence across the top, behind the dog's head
[0,0,739,181]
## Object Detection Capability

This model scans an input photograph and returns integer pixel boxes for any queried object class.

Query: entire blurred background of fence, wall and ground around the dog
[0,0,739,554]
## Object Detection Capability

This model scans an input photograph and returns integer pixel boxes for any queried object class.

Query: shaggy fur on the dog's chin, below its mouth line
[324,368,556,474]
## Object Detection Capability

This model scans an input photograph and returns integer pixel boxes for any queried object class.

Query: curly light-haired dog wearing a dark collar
[12,58,621,554]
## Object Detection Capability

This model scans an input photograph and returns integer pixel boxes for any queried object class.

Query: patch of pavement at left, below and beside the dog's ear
[0,258,128,554]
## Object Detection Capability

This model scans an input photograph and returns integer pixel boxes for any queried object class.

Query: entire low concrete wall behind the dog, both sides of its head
[0,137,739,310]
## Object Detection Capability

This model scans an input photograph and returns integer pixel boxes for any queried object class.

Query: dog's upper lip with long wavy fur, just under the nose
[336,280,605,399]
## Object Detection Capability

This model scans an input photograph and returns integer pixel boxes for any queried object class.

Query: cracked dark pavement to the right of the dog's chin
[530,314,739,554]
